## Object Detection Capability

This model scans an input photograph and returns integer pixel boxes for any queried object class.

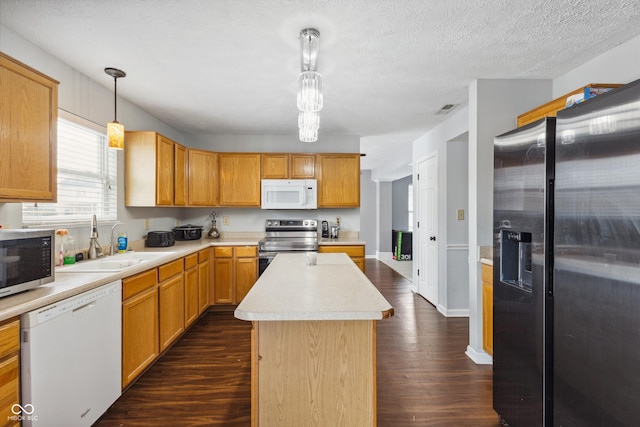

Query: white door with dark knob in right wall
[418,154,438,307]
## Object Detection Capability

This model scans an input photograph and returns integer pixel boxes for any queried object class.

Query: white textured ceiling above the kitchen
[0,0,640,174]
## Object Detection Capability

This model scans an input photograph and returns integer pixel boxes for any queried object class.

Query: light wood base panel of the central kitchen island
[251,320,376,427]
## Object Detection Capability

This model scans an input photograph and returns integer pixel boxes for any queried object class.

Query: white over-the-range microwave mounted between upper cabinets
[261,179,318,209]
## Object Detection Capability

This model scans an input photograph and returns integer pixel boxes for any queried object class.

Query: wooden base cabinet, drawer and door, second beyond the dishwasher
[158,259,184,352]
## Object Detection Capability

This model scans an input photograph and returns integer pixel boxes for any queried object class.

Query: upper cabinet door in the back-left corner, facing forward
[188,149,218,206]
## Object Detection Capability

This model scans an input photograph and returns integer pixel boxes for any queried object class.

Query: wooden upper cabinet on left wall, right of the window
[124,131,187,206]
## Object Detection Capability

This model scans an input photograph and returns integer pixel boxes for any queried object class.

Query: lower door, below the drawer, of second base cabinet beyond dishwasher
[158,274,184,352]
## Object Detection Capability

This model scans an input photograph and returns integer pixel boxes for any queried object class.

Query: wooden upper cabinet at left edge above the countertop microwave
[0,52,58,202]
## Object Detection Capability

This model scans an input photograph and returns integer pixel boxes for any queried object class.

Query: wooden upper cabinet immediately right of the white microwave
[316,154,360,208]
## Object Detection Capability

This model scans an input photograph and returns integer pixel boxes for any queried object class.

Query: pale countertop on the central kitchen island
[235,253,393,321]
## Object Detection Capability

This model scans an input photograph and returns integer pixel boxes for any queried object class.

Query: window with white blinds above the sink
[22,111,118,225]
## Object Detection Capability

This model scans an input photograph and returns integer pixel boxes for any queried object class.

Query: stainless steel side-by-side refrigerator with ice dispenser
[493,82,640,427]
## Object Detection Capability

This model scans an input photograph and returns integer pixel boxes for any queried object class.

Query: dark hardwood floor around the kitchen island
[95,260,500,427]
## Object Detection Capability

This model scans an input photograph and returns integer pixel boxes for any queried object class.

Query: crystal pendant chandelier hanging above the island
[297,28,323,142]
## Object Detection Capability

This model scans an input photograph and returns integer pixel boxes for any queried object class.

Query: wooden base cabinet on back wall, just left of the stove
[213,246,258,304]
